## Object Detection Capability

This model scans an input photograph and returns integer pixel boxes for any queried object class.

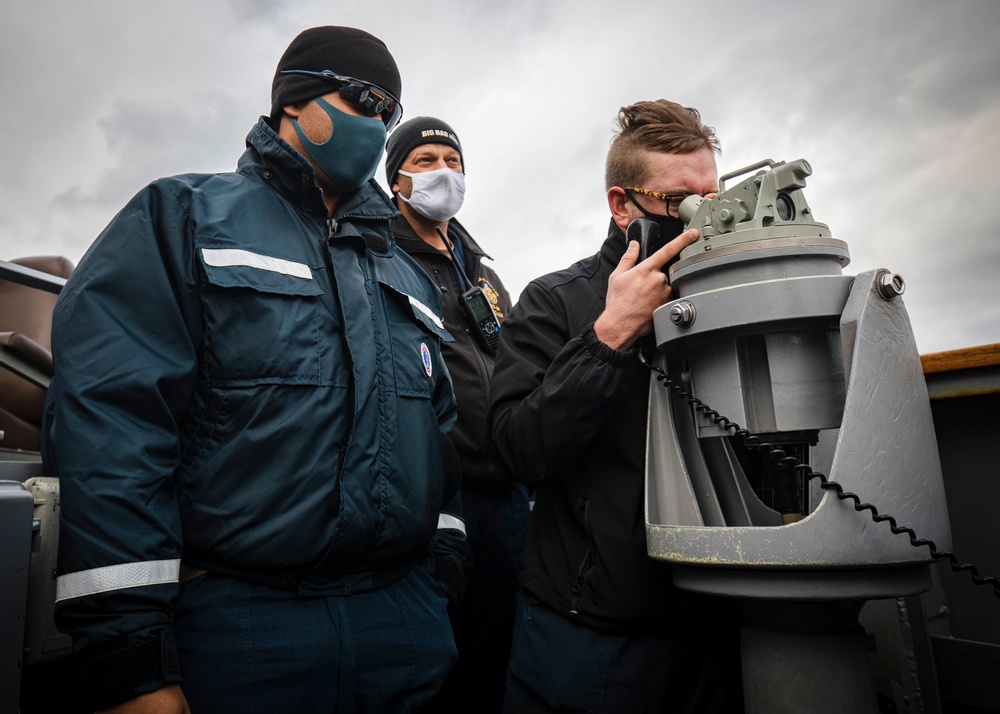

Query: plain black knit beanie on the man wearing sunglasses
[271,25,402,118]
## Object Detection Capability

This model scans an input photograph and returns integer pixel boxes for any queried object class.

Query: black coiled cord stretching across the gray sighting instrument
[638,352,1000,598]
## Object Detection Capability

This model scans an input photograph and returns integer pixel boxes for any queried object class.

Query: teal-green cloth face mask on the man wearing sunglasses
[292,97,386,192]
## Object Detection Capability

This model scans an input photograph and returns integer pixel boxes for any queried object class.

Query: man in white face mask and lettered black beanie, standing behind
[386,117,529,712]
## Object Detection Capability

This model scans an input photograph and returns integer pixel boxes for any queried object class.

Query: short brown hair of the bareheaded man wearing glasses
[604,99,721,189]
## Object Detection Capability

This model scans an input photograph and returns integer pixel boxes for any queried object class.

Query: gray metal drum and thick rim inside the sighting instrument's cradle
[653,275,853,436]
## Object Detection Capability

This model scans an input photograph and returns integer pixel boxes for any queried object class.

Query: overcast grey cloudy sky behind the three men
[0,0,1000,353]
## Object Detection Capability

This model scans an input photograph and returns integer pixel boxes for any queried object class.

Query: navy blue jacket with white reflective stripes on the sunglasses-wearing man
[52,119,455,649]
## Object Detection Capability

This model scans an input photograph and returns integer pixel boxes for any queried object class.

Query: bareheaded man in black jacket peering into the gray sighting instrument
[490,100,738,714]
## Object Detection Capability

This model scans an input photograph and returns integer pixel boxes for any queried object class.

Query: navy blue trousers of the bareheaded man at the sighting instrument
[503,590,743,714]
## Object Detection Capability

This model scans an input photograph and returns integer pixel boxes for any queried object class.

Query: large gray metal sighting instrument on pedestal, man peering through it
[646,159,951,714]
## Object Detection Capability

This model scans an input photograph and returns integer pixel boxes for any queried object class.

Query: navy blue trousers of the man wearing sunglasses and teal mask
[174,566,456,714]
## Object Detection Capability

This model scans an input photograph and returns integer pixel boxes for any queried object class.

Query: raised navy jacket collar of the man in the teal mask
[237,117,399,222]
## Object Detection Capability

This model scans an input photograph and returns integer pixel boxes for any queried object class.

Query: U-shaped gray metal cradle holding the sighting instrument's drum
[647,271,951,576]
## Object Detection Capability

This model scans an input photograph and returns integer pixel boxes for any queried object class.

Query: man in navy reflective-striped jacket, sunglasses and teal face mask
[52,27,463,712]
